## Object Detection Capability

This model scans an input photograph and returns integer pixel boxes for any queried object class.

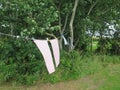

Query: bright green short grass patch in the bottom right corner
[99,64,120,90]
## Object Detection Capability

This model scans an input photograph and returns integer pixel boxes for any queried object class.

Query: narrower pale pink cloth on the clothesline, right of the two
[50,38,60,67]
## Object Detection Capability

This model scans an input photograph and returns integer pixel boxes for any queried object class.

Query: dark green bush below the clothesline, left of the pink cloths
[0,38,45,84]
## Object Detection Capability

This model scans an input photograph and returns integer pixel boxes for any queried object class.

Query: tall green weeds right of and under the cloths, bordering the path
[38,51,120,83]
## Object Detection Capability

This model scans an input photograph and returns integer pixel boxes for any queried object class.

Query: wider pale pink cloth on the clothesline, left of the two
[33,39,55,74]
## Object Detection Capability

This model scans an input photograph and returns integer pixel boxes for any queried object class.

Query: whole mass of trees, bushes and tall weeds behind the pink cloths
[0,0,120,85]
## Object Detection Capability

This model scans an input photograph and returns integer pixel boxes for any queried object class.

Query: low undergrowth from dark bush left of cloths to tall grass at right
[0,38,120,85]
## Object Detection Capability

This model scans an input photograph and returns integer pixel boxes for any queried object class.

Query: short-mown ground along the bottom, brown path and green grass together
[0,64,120,90]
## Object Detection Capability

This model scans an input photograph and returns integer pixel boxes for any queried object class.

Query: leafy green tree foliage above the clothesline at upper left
[0,0,59,38]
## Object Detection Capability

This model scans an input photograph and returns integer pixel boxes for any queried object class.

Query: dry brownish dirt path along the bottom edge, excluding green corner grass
[0,73,105,90]
